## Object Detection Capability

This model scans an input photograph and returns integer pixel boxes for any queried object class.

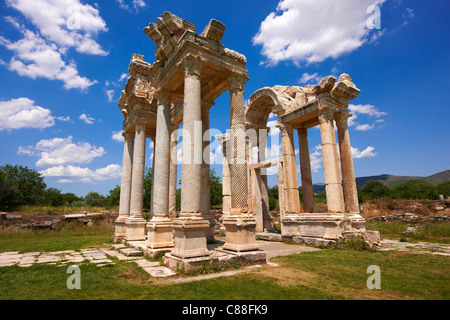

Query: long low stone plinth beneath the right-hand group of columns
[281,213,365,240]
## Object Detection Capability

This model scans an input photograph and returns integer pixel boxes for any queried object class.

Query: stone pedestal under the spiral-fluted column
[222,215,259,252]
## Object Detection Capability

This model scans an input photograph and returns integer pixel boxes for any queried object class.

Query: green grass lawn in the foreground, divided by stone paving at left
[0,226,450,300]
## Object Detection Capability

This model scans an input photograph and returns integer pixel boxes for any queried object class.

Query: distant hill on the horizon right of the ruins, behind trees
[313,170,450,193]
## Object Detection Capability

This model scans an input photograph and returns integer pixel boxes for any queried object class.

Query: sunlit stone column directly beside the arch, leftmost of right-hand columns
[278,123,300,215]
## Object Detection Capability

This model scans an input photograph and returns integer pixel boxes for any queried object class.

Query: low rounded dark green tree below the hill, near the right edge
[391,180,439,200]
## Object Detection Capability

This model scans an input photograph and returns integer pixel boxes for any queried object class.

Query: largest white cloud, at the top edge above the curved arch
[253,0,385,65]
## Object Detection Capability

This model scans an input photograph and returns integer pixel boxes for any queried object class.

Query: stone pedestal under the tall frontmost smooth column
[170,213,209,259]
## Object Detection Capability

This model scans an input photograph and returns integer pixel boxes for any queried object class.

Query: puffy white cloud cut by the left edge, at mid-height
[0,98,55,131]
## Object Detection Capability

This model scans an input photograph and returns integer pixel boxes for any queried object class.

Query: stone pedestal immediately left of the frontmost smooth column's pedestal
[147,217,174,249]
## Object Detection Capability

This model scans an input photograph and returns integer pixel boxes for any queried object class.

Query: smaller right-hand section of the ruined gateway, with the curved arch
[246,74,365,240]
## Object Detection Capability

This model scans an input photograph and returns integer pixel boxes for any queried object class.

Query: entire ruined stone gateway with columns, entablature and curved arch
[114,12,372,269]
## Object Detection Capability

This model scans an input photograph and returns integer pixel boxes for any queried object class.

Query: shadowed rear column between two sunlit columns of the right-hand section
[297,128,314,213]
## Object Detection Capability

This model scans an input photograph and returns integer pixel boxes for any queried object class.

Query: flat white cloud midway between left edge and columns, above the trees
[17,136,106,167]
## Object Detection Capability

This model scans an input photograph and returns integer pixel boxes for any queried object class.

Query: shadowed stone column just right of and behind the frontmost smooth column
[201,101,217,240]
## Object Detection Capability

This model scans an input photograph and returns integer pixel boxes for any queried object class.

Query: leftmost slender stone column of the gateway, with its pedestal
[114,132,134,241]
